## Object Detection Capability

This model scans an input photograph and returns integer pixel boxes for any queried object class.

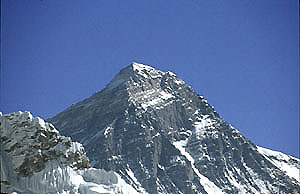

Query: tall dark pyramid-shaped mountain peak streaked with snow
[49,63,300,193]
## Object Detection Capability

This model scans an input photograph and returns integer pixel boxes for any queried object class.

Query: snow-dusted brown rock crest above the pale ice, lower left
[0,111,89,177]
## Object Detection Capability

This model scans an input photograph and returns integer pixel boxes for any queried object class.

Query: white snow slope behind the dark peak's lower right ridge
[256,146,300,182]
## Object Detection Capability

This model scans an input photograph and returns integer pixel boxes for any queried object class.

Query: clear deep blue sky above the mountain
[0,0,299,157]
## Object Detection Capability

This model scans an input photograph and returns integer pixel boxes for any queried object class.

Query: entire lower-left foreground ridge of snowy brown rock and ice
[0,112,137,194]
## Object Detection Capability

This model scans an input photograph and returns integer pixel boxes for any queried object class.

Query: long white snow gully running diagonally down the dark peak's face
[173,139,224,194]
